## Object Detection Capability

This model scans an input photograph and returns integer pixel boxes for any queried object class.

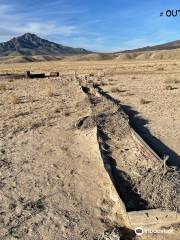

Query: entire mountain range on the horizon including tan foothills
[0,33,180,63]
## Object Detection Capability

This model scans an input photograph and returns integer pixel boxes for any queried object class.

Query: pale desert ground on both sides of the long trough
[0,60,180,240]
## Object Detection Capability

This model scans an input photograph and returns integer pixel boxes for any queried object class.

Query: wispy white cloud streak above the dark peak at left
[0,4,79,41]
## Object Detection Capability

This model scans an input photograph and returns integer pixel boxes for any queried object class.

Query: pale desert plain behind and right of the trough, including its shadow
[3,60,177,166]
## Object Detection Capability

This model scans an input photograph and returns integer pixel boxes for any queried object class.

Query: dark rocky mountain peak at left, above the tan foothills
[0,33,90,57]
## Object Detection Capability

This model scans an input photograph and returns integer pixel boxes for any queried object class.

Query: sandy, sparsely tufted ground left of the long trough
[0,80,126,240]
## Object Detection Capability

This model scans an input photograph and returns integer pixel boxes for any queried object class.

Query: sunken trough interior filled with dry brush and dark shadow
[74,75,180,214]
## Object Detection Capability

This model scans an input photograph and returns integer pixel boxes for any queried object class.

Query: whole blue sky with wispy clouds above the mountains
[0,0,180,52]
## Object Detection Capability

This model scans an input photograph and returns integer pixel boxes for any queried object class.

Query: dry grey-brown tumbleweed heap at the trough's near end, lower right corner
[135,162,180,212]
